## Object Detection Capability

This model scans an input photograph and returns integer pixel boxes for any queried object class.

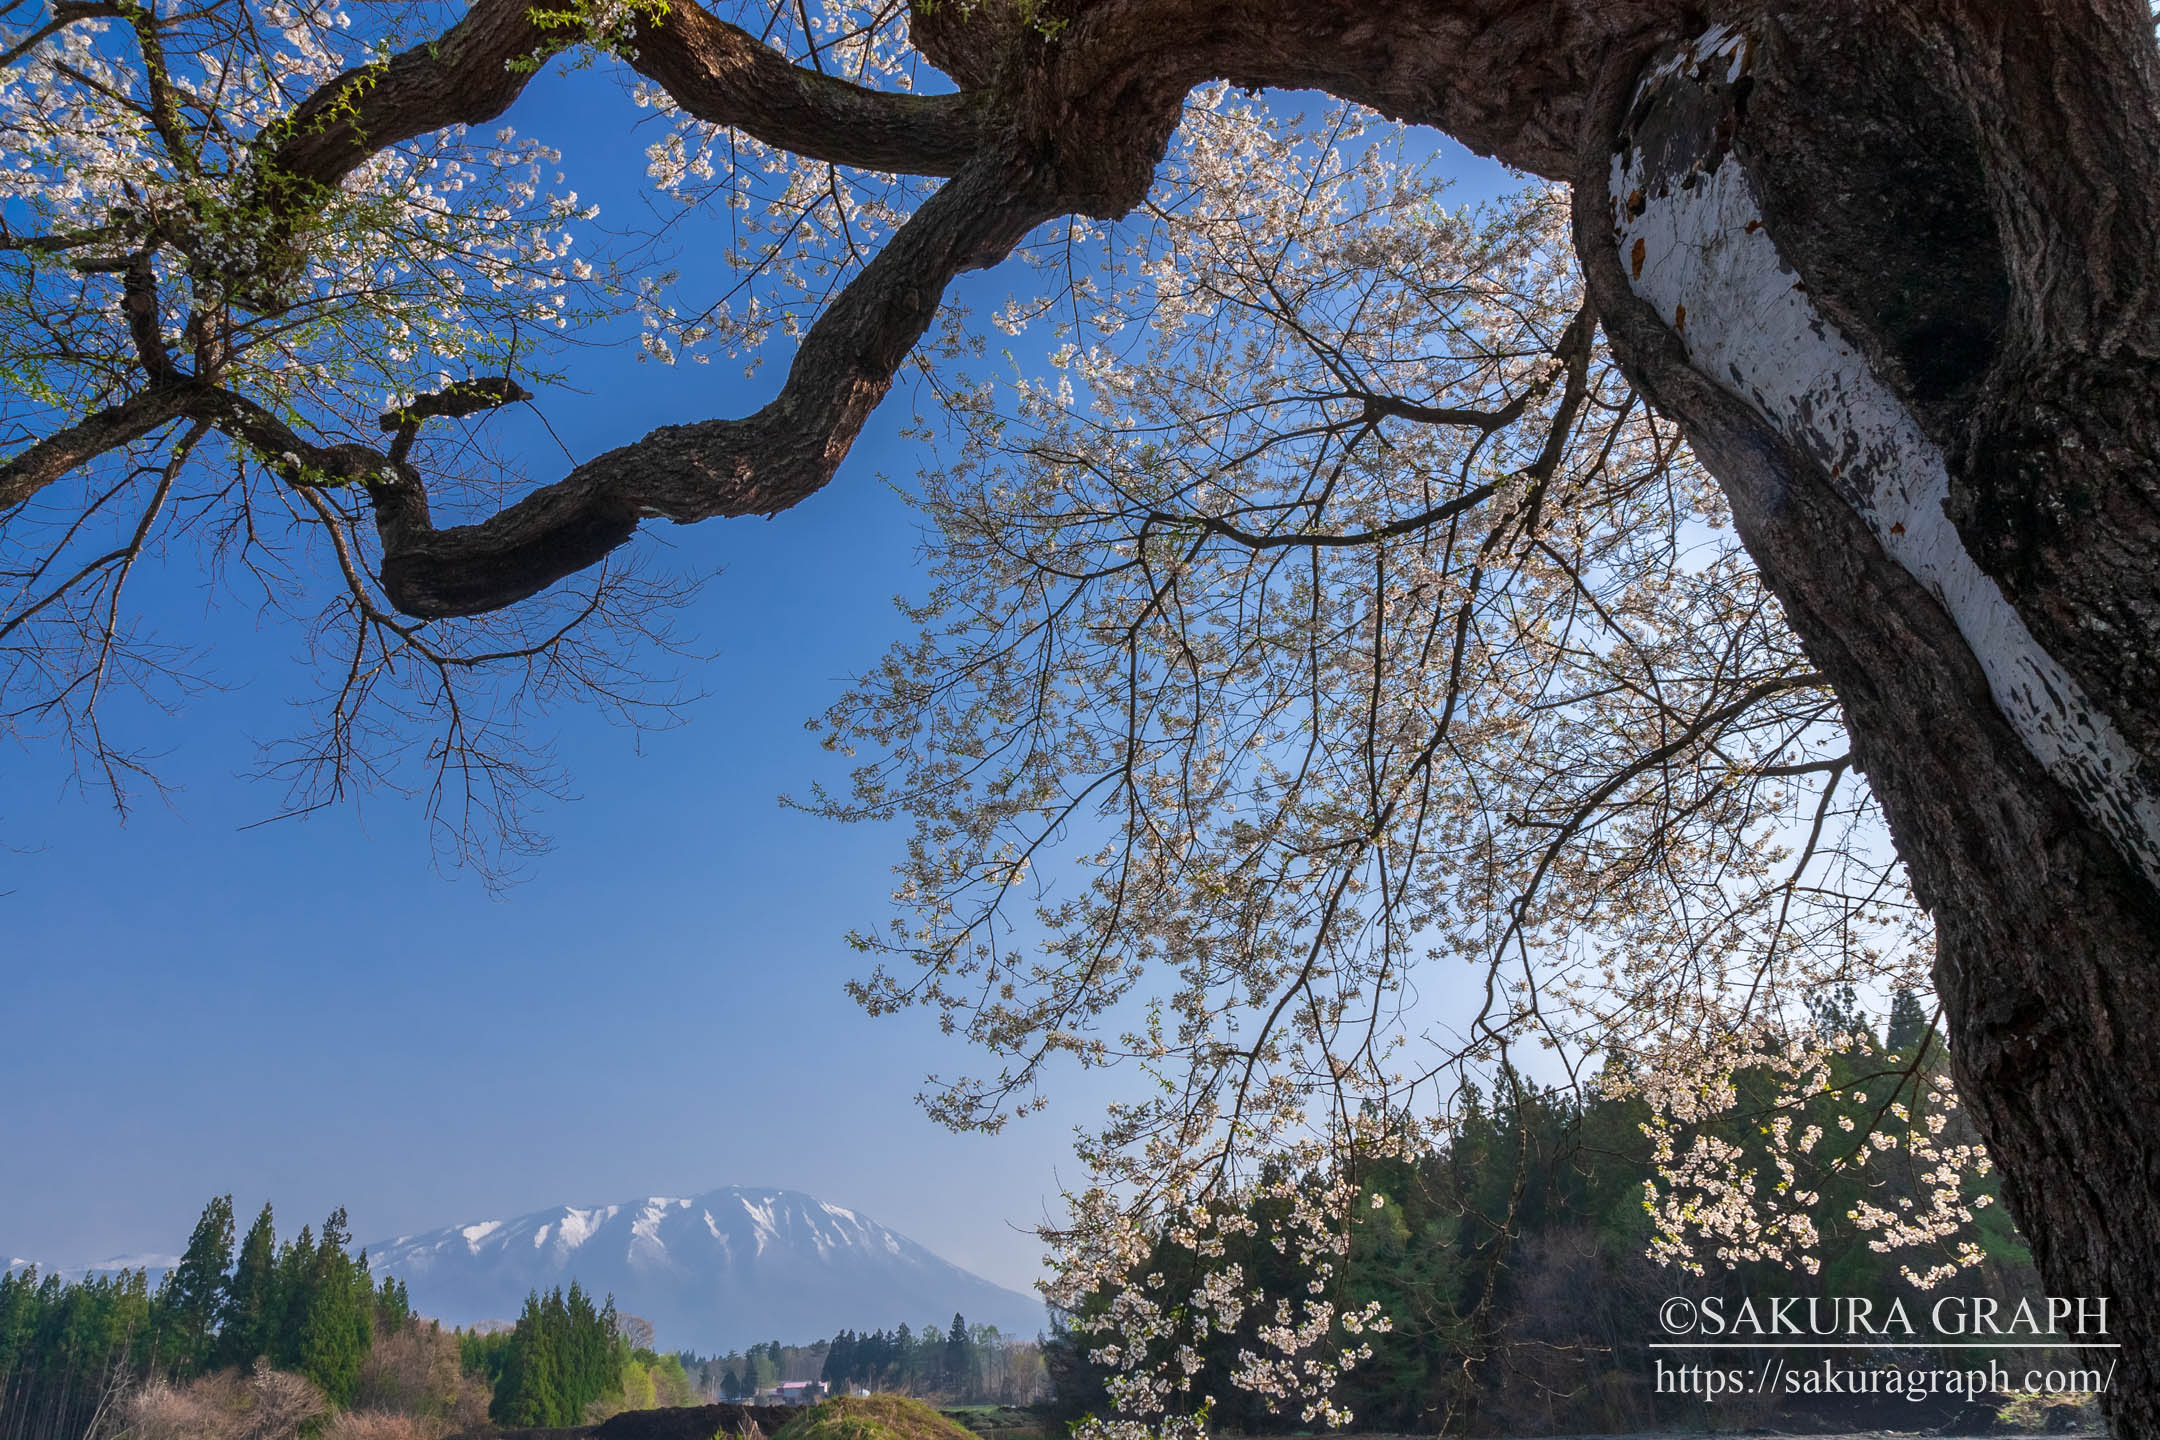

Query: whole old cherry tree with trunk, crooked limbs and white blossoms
[12,0,2160,1434]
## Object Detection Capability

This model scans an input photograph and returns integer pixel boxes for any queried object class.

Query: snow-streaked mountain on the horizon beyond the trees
[367,1185,1043,1354]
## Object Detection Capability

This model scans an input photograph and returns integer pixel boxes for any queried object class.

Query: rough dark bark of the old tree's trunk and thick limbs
[0,0,2160,1436]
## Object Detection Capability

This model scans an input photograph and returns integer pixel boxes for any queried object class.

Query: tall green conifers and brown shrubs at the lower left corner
[0,1196,698,1440]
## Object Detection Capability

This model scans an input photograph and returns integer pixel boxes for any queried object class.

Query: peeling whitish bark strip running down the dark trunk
[1611,26,2160,885]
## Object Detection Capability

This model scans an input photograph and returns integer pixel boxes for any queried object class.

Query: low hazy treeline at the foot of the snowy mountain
[680,1315,1050,1405]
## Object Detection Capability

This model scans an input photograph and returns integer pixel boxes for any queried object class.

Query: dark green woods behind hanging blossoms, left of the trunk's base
[1045,993,2041,1436]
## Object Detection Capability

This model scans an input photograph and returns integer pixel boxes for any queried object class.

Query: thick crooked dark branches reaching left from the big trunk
[11,0,1665,617]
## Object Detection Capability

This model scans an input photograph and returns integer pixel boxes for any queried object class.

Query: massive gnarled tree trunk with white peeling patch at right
[1572,0,2160,1436]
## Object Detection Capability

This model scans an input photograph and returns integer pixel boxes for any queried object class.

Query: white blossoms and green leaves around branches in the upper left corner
[0,0,613,436]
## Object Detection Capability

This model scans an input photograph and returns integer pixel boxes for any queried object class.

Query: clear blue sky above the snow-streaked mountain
[0,45,1506,1287]
